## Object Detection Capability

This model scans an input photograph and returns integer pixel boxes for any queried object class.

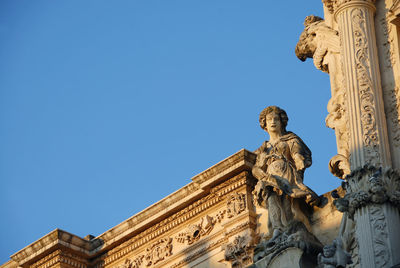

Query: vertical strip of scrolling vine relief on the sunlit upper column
[351,8,380,165]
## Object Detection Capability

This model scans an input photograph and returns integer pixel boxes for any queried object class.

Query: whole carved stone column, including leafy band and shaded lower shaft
[323,0,400,268]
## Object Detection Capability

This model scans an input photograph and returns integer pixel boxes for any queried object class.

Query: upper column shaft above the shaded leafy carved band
[335,0,391,170]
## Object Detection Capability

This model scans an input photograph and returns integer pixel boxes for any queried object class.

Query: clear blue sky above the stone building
[0,0,340,263]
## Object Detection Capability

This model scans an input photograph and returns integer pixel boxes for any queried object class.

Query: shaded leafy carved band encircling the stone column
[334,166,400,217]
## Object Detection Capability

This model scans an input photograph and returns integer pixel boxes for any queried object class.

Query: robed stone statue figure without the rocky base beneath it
[252,106,319,236]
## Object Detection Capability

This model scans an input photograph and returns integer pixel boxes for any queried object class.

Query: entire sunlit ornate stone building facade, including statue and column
[0,0,400,268]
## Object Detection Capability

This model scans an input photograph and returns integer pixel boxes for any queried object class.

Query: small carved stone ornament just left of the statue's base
[224,235,254,268]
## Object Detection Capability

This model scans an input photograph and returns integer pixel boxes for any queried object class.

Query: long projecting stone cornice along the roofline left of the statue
[5,149,256,267]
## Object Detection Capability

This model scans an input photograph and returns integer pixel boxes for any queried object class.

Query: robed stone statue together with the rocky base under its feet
[252,106,322,258]
